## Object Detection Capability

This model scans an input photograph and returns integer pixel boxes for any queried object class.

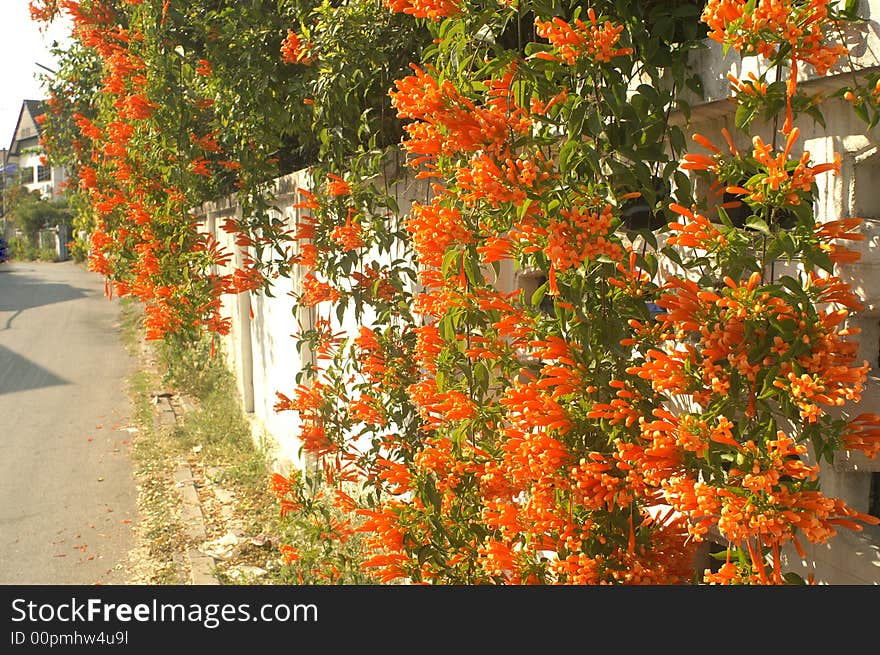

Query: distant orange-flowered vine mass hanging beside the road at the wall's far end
[34,0,282,346]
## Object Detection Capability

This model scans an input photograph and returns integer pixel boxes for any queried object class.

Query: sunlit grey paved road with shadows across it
[0,262,137,584]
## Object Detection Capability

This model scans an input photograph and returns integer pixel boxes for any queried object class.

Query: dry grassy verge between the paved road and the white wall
[120,298,281,584]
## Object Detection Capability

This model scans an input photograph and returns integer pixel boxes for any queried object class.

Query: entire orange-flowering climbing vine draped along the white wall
[33,0,880,584]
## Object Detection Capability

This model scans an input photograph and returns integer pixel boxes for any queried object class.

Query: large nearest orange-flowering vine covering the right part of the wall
[276,3,878,584]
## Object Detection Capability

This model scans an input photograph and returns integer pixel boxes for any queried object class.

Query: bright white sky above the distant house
[0,0,70,148]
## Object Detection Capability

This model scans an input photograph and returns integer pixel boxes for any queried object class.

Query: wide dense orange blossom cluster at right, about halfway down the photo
[631,273,867,416]
